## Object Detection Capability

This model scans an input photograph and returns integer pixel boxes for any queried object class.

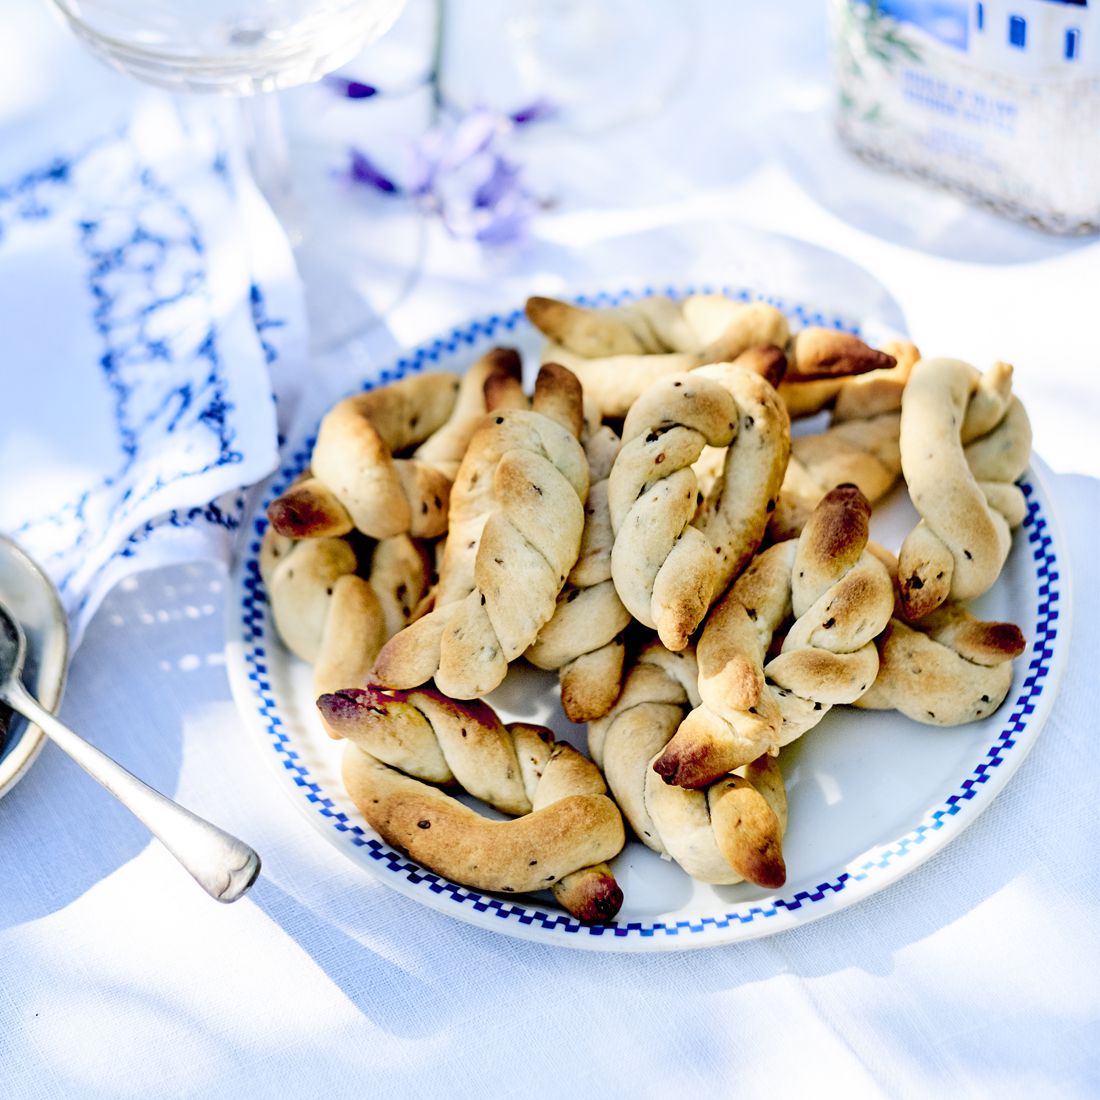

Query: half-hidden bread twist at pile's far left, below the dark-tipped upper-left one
[260,526,431,697]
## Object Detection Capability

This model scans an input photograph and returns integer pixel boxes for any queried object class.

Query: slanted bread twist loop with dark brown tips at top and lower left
[653,485,893,787]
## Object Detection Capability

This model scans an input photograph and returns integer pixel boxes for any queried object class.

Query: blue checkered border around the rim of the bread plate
[232,285,1060,938]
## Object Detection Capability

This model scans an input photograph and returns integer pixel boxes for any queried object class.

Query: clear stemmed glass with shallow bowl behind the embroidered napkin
[52,0,405,349]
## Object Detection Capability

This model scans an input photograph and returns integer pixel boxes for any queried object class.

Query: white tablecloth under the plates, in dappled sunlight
[0,0,1100,1098]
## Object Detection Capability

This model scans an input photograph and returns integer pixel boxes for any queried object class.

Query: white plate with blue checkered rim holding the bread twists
[227,286,1069,952]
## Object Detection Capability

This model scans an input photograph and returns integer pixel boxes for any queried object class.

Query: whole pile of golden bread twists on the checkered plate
[261,295,1031,921]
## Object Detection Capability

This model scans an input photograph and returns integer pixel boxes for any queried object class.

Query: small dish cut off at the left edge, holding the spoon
[0,535,68,799]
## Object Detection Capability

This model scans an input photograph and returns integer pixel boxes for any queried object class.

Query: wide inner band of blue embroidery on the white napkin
[0,132,253,594]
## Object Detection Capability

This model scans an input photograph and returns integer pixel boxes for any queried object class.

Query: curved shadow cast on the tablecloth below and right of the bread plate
[245,475,1100,1049]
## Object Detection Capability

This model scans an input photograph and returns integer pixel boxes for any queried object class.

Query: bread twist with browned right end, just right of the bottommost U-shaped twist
[589,641,787,888]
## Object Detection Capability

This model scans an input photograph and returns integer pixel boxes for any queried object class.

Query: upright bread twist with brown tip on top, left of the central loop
[374,365,589,699]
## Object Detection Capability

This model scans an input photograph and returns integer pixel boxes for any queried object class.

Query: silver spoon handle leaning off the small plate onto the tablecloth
[0,681,260,902]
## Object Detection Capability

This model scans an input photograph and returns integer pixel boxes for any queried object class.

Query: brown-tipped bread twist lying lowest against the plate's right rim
[856,545,1026,726]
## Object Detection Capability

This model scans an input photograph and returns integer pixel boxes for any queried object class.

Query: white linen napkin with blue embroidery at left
[0,92,306,639]
